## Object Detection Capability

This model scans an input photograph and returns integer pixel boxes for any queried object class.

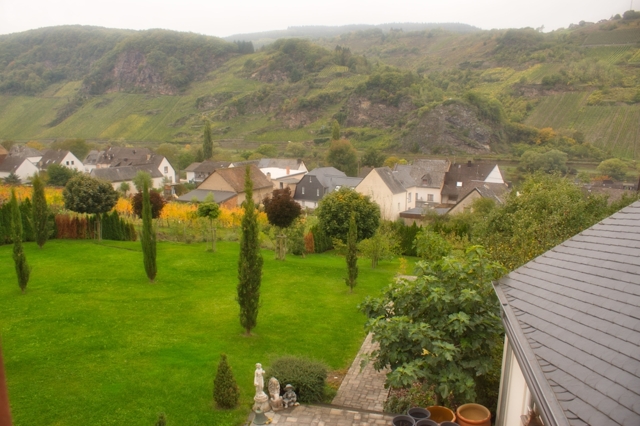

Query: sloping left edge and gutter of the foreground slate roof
[493,281,570,426]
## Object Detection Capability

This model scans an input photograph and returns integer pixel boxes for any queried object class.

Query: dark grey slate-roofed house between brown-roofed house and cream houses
[293,167,362,209]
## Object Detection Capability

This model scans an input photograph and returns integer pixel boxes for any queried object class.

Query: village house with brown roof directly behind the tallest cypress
[198,164,273,206]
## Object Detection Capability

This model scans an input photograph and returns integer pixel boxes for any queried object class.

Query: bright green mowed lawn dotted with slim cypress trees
[0,240,399,426]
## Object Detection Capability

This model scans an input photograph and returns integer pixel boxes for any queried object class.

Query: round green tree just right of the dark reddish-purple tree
[316,187,380,242]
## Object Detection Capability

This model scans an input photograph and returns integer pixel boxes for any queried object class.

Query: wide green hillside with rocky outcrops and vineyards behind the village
[0,12,640,160]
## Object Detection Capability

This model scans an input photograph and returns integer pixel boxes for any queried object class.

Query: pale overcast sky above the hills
[0,0,640,37]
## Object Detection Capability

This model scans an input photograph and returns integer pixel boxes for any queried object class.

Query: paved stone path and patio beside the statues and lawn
[252,334,393,426]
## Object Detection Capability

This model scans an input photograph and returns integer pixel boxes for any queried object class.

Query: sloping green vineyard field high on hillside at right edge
[526,92,640,159]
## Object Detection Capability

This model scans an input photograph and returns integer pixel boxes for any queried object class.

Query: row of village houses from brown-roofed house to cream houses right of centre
[178,158,508,221]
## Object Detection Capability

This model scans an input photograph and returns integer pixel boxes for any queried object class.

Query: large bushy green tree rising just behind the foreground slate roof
[473,173,616,270]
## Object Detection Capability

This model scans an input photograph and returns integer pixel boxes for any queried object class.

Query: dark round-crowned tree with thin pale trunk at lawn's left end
[62,174,118,240]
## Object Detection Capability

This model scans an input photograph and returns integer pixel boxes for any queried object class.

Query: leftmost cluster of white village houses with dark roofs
[0,146,176,193]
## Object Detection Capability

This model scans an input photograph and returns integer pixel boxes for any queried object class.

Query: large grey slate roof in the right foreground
[495,202,640,426]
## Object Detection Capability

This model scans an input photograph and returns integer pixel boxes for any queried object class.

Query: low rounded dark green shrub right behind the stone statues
[266,356,327,403]
